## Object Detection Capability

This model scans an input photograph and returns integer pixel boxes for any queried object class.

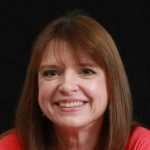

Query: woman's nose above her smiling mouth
[59,71,79,95]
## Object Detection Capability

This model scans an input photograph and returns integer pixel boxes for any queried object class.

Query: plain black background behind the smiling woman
[0,0,150,133]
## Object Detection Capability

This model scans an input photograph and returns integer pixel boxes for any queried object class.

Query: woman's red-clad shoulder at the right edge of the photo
[127,126,150,150]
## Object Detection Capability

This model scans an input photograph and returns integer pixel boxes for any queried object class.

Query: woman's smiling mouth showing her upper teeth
[55,101,87,108]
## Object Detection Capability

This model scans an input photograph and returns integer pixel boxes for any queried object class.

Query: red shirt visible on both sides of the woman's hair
[0,126,150,150]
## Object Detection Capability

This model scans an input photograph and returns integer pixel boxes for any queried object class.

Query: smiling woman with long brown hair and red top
[0,10,150,150]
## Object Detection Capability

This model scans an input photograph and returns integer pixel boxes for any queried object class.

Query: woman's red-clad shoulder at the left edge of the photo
[0,130,21,150]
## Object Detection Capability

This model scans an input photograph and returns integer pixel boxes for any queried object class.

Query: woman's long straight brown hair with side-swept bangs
[16,9,132,150]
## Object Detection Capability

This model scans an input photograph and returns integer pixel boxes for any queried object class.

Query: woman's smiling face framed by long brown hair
[38,43,108,127]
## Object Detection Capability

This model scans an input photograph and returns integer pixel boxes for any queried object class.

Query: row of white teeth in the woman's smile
[59,102,84,108]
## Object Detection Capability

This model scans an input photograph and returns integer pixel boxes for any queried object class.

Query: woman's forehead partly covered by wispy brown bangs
[41,40,96,64]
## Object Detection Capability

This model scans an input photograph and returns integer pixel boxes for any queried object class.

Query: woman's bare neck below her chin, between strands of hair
[56,122,101,150]
